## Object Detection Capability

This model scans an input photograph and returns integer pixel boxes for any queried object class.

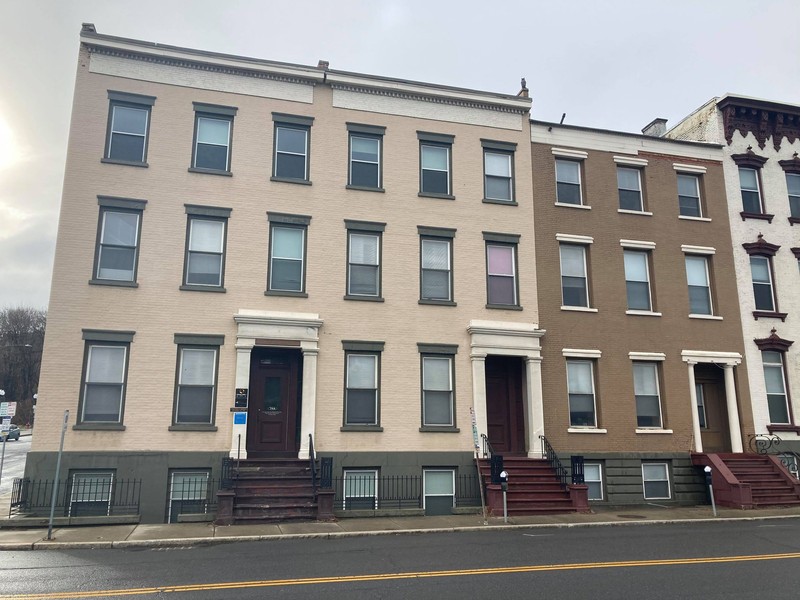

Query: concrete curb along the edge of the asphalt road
[0,515,800,551]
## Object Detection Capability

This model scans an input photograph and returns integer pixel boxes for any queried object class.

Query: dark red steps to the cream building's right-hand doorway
[478,455,577,516]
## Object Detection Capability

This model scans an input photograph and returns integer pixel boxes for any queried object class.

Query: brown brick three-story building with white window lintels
[531,121,752,504]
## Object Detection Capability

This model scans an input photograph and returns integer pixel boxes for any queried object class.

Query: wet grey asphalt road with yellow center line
[0,519,800,600]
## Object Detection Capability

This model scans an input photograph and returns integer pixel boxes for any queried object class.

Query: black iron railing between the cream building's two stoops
[331,472,480,511]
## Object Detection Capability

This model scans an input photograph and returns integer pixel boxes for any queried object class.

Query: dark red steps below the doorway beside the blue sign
[227,458,317,525]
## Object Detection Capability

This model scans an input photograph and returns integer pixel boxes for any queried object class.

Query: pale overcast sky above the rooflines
[0,0,800,309]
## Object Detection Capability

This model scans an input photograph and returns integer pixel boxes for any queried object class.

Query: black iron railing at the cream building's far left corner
[9,477,142,517]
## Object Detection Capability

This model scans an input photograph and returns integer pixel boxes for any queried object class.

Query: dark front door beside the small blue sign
[247,348,300,457]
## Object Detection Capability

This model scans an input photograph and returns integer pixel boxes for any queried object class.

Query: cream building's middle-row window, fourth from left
[345,220,386,300]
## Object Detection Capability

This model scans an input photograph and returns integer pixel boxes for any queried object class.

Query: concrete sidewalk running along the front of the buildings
[0,504,800,550]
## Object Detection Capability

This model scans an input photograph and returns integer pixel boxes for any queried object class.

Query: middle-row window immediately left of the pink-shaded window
[417,227,455,304]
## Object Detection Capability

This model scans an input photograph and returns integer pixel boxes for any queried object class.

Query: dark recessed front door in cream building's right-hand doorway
[486,356,525,454]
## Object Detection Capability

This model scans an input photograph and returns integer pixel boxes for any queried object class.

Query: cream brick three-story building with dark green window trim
[26,25,544,522]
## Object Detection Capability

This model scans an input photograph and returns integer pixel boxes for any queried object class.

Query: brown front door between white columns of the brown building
[694,364,731,452]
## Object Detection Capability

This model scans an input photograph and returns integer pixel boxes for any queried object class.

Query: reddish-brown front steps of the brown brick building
[692,453,800,508]
